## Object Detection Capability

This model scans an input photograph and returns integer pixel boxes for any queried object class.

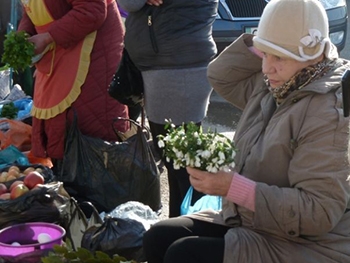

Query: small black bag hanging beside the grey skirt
[108,48,143,106]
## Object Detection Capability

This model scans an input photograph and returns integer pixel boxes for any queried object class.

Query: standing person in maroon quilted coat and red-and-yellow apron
[18,0,128,169]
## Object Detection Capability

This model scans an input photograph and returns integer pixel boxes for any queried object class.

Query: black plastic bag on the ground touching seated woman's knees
[81,216,146,262]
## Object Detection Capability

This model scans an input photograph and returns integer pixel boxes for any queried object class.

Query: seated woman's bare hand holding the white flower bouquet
[186,167,233,196]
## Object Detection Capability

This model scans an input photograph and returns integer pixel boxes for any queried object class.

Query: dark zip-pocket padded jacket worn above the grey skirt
[118,0,218,70]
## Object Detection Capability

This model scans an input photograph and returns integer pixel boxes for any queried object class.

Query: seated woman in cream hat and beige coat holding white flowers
[143,0,350,263]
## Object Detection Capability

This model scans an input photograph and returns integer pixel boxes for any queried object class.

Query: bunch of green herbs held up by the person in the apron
[0,31,35,72]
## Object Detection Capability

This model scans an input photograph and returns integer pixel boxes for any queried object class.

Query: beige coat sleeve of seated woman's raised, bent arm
[207,34,263,110]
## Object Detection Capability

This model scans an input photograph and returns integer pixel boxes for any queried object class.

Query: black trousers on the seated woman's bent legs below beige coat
[143,217,229,263]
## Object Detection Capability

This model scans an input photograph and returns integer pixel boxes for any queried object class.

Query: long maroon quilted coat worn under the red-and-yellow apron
[18,0,128,159]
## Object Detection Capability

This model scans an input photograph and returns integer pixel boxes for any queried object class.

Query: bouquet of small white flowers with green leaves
[158,121,236,173]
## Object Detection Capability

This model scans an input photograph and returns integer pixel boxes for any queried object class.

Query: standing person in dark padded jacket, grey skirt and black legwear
[118,0,218,217]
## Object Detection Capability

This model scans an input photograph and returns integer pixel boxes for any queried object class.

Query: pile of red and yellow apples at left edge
[0,165,45,200]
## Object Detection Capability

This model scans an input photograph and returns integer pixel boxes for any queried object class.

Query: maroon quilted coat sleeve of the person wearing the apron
[48,0,107,48]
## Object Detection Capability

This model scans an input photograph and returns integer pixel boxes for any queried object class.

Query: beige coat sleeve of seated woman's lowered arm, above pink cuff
[254,92,350,237]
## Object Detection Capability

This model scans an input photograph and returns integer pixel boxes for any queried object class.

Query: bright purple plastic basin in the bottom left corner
[0,222,66,256]
